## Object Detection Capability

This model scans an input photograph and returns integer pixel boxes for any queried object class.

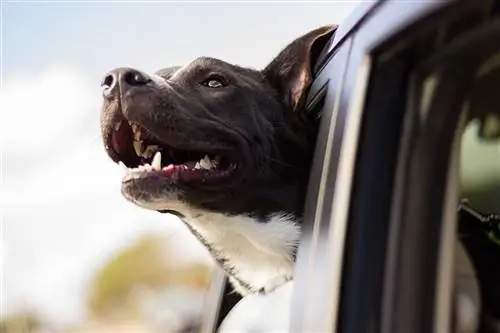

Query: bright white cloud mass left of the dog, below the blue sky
[0,67,208,323]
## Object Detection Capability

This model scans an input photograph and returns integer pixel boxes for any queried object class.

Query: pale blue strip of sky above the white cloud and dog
[4,1,354,78]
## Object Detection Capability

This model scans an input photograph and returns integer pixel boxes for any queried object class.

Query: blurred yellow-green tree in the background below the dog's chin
[89,236,211,319]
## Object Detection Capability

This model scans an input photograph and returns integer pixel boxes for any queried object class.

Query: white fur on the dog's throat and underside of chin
[129,198,300,295]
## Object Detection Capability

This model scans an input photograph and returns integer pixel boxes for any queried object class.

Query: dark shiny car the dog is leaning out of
[195,0,500,333]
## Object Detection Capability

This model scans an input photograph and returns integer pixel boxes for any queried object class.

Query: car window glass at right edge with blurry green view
[455,54,500,333]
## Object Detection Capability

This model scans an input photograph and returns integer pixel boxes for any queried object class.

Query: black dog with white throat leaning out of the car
[101,26,337,296]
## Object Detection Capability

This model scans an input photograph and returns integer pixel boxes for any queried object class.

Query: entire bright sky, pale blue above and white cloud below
[0,0,356,323]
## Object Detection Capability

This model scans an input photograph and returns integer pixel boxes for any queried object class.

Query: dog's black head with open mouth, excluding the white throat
[101,26,335,215]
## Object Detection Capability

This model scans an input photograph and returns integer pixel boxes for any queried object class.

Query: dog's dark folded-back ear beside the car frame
[262,25,337,112]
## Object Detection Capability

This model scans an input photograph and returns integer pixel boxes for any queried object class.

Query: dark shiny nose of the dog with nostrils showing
[101,68,151,97]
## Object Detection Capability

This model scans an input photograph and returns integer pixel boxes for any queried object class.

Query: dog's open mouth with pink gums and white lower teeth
[110,120,237,184]
